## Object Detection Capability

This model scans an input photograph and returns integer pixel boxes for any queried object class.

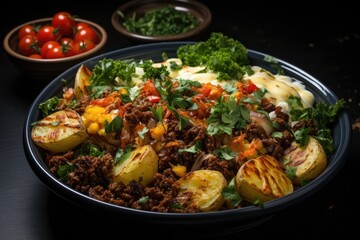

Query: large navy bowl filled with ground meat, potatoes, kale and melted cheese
[24,34,350,224]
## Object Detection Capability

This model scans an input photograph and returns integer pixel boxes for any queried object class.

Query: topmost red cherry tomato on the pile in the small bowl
[52,12,76,36]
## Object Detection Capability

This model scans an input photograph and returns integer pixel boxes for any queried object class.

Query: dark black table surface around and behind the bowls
[0,0,360,240]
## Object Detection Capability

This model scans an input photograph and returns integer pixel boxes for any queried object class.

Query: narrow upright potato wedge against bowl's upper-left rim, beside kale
[74,65,92,100]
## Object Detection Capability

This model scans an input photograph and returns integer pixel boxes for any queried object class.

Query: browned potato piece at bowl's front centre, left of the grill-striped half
[174,170,227,212]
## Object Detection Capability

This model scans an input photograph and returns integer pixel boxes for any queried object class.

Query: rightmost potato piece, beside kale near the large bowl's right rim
[282,137,327,185]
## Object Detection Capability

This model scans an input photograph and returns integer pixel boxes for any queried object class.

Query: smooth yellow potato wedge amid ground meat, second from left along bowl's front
[113,145,158,186]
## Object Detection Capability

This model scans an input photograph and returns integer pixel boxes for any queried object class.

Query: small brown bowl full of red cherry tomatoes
[3,12,107,80]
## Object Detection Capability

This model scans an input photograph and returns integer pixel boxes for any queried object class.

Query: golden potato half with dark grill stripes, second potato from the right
[236,155,294,203]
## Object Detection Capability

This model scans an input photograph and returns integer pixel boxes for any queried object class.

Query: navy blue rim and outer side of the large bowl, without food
[23,42,351,231]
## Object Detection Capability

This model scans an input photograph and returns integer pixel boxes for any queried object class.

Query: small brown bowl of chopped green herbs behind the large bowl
[111,0,212,42]
